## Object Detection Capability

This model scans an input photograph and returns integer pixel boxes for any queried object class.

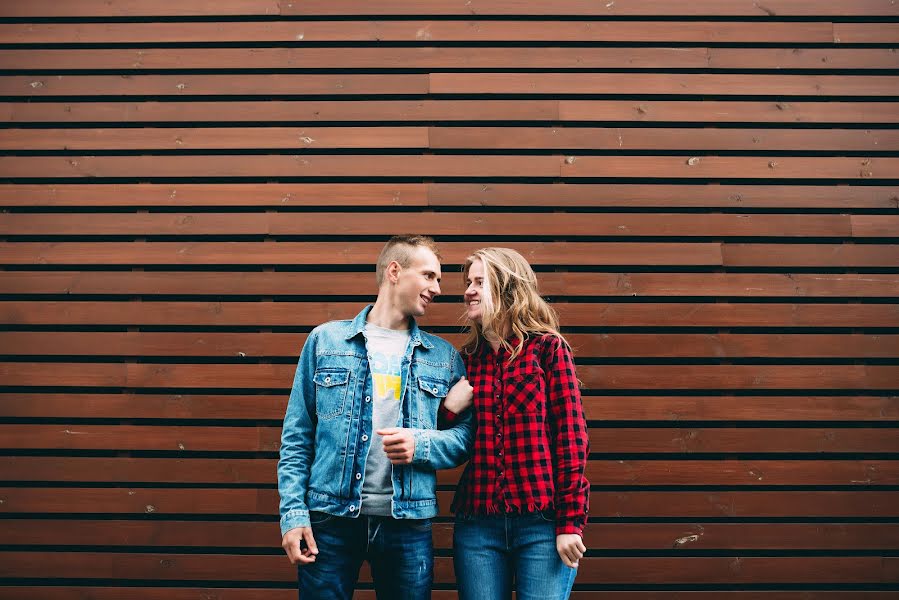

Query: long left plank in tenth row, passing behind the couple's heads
[0,241,724,264]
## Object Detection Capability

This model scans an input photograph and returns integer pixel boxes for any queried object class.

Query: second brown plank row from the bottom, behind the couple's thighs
[0,551,899,584]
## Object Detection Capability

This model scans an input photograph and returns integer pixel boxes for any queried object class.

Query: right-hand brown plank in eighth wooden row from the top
[426,182,899,210]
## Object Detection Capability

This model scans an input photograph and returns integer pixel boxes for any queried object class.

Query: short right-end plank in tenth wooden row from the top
[722,243,899,267]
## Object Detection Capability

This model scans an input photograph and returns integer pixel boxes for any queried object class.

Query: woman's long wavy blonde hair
[462,248,568,360]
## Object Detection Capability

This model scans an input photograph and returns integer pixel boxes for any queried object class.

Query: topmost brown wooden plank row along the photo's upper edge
[7,0,899,18]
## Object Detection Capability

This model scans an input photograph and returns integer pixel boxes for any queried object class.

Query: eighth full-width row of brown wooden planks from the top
[0,183,899,210]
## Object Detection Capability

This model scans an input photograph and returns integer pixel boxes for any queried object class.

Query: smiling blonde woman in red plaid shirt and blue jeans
[446,248,590,600]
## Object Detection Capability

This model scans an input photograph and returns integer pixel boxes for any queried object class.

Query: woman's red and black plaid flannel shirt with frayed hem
[446,335,590,535]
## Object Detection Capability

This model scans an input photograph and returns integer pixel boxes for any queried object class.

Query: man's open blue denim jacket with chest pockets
[278,306,474,535]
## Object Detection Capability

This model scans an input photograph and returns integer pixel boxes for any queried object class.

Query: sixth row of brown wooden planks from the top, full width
[7,127,899,152]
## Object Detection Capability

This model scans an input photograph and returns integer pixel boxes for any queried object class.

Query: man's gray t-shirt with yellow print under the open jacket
[360,323,411,516]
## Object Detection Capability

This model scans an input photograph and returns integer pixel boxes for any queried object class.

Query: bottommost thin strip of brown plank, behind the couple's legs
[0,586,895,600]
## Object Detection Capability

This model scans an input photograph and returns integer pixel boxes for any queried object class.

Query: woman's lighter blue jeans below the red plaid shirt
[453,513,577,600]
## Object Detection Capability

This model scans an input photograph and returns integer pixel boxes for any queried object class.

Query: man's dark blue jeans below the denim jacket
[297,511,434,600]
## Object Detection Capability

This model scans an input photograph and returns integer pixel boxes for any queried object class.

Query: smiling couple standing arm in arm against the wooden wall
[278,236,589,600]
